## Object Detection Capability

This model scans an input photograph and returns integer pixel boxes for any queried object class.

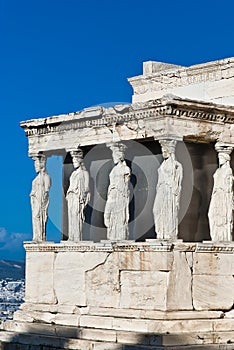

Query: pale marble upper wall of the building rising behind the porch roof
[129,57,234,105]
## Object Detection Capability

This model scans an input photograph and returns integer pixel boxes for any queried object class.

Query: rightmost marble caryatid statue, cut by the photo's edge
[208,143,234,241]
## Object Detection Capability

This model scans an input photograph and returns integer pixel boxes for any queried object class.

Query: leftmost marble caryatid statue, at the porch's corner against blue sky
[30,154,51,242]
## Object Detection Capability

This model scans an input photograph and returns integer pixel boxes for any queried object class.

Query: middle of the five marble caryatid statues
[104,143,131,240]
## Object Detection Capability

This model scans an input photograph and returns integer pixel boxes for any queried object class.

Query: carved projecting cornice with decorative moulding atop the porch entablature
[20,95,234,137]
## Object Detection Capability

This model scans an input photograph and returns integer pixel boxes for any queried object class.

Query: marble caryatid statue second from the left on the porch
[66,149,90,242]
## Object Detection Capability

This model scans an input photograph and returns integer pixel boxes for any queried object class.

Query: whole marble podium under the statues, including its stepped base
[5,239,234,350]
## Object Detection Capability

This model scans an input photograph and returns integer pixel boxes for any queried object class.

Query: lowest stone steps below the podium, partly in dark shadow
[0,323,233,350]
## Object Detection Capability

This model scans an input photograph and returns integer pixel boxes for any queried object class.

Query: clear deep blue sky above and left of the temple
[0,0,234,259]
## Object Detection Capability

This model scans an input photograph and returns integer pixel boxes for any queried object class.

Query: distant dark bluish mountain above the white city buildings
[0,260,25,280]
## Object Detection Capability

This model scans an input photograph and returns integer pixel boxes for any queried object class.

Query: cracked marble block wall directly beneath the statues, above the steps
[22,241,234,311]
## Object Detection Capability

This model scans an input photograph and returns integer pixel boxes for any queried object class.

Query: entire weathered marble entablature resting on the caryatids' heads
[20,95,234,155]
